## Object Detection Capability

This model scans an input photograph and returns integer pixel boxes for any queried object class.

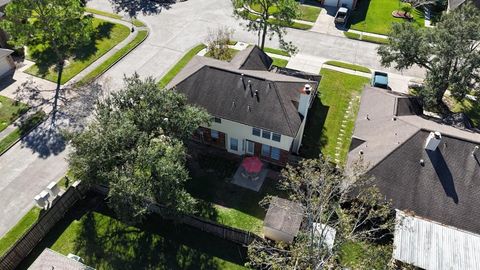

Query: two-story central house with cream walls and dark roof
[167,46,320,165]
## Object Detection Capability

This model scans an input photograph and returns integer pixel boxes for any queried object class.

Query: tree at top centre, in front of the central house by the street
[232,0,299,53]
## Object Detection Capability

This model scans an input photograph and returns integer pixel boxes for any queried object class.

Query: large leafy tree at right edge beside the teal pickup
[378,3,480,114]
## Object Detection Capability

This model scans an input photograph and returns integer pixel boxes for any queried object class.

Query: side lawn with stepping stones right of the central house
[301,68,369,163]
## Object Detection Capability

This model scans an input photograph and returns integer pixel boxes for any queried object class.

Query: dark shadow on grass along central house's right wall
[300,98,330,158]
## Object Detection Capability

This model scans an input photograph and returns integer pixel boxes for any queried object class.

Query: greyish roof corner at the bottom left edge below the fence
[28,248,94,270]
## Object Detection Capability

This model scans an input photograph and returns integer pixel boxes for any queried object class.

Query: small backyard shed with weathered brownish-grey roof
[263,197,303,243]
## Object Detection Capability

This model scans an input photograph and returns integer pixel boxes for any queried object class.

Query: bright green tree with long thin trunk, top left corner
[1,0,93,121]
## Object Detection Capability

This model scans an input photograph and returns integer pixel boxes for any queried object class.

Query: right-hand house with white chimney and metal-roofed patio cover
[348,87,480,269]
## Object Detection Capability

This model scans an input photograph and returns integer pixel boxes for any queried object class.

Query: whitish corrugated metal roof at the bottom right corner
[393,211,480,270]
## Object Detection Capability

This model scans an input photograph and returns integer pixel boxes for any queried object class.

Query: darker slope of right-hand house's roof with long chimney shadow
[370,130,480,233]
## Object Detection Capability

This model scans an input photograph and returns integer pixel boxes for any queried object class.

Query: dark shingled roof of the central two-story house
[167,47,319,137]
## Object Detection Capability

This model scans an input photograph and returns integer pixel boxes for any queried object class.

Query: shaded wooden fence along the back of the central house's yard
[93,185,263,245]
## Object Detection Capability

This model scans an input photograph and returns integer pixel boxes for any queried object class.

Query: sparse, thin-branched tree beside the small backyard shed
[248,159,395,269]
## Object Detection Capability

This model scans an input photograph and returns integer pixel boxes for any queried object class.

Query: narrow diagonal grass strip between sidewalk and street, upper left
[78,30,148,85]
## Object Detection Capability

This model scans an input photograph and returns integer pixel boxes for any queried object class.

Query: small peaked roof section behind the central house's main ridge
[230,46,273,70]
